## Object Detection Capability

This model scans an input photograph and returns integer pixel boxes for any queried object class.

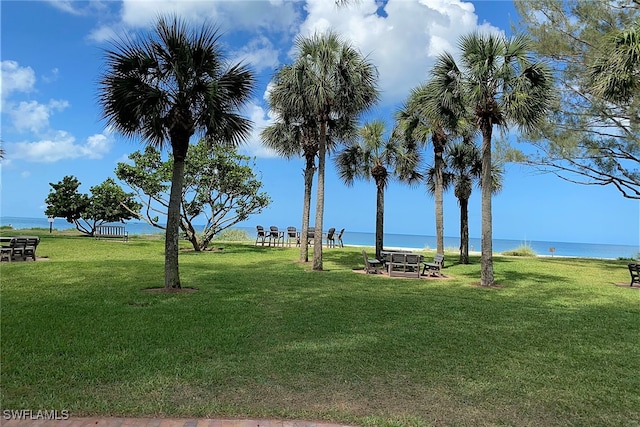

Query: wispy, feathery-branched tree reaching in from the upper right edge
[511,0,640,199]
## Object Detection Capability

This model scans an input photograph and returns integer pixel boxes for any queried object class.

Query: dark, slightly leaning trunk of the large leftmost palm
[164,152,188,289]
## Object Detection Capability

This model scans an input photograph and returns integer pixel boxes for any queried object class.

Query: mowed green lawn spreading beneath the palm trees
[0,232,640,426]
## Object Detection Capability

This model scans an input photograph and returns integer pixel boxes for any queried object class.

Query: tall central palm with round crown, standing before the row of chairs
[286,31,378,270]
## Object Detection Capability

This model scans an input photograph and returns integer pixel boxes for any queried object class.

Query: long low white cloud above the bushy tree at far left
[7,131,112,163]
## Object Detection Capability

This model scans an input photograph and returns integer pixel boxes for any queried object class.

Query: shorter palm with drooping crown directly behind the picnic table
[335,120,422,259]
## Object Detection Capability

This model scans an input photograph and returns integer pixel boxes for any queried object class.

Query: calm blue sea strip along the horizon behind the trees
[0,217,640,259]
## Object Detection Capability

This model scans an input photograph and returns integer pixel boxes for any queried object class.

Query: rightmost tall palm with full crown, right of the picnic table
[434,33,553,286]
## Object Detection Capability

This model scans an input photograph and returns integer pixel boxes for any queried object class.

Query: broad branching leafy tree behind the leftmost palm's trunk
[116,140,270,251]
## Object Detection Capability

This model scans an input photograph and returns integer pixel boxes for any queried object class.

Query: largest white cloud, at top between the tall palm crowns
[300,0,498,104]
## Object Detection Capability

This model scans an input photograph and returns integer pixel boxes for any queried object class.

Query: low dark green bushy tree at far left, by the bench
[45,176,142,236]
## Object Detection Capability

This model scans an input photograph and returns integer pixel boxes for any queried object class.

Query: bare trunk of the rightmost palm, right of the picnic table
[480,118,494,286]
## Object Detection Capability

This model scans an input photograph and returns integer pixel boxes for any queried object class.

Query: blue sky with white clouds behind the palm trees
[0,0,640,246]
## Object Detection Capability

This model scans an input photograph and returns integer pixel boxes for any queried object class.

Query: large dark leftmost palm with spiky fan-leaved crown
[99,16,254,288]
